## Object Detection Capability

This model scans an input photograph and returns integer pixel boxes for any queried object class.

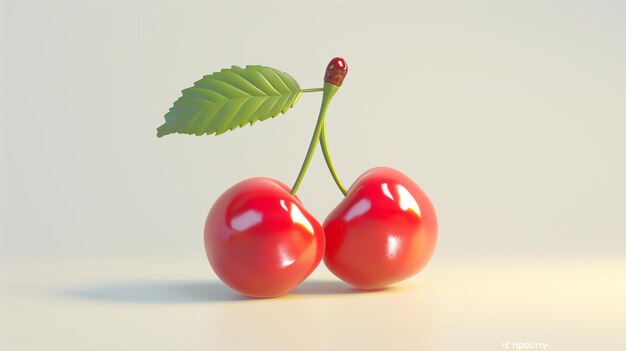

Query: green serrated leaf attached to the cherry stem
[157,66,301,137]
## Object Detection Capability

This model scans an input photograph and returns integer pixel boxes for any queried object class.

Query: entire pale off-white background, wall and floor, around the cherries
[0,0,626,350]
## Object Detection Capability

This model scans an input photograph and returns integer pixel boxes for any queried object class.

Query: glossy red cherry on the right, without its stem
[324,167,437,289]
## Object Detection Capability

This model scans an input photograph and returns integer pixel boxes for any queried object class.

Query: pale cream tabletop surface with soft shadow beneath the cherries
[0,258,626,351]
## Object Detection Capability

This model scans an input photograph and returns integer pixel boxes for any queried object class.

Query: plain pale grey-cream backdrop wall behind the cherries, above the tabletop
[0,0,626,259]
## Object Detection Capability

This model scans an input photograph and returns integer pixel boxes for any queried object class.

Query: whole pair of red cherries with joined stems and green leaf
[157,57,437,297]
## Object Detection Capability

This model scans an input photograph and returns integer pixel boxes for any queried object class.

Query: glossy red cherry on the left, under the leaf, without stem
[204,178,324,297]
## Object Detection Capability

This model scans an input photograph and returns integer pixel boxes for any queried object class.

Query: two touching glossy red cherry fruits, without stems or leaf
[204,167,437,297]
